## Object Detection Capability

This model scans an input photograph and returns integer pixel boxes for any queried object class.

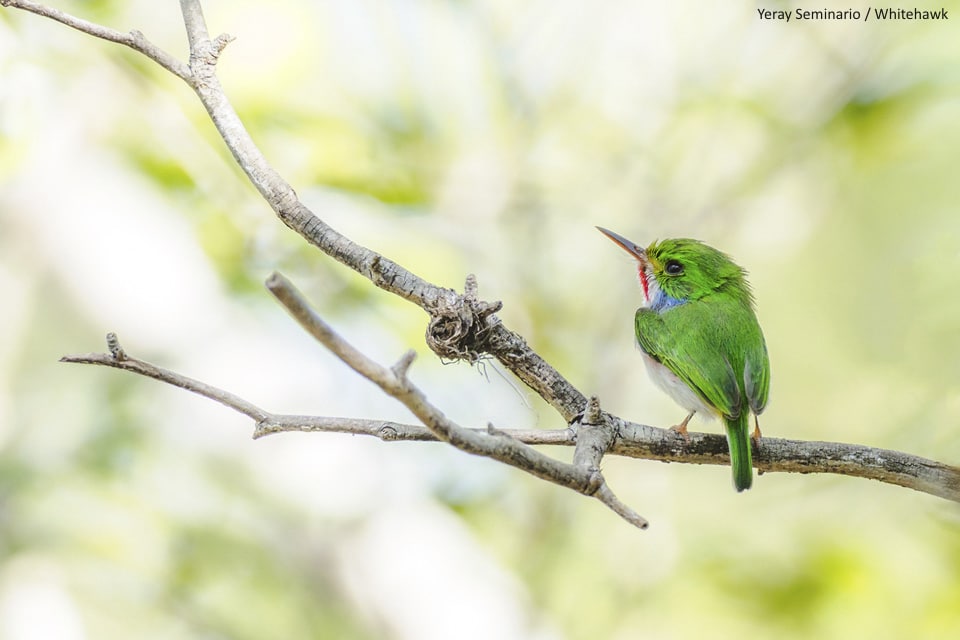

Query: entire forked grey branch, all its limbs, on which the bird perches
[9,0,960,526]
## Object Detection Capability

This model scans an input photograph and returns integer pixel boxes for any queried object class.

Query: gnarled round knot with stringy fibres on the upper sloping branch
[426,274,503,364]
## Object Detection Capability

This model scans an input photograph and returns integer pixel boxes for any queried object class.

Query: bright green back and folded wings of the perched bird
[636,298,770,419]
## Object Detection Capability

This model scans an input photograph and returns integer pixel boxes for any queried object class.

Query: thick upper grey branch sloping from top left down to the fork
[0,0,586,421]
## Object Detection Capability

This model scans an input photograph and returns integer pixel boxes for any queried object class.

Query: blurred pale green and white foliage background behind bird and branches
[0,0,960,640]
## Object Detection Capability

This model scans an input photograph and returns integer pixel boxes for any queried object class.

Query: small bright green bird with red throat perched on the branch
[597,227,770,491]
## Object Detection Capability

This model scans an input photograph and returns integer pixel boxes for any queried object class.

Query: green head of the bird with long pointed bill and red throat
[597,227,753,310]
